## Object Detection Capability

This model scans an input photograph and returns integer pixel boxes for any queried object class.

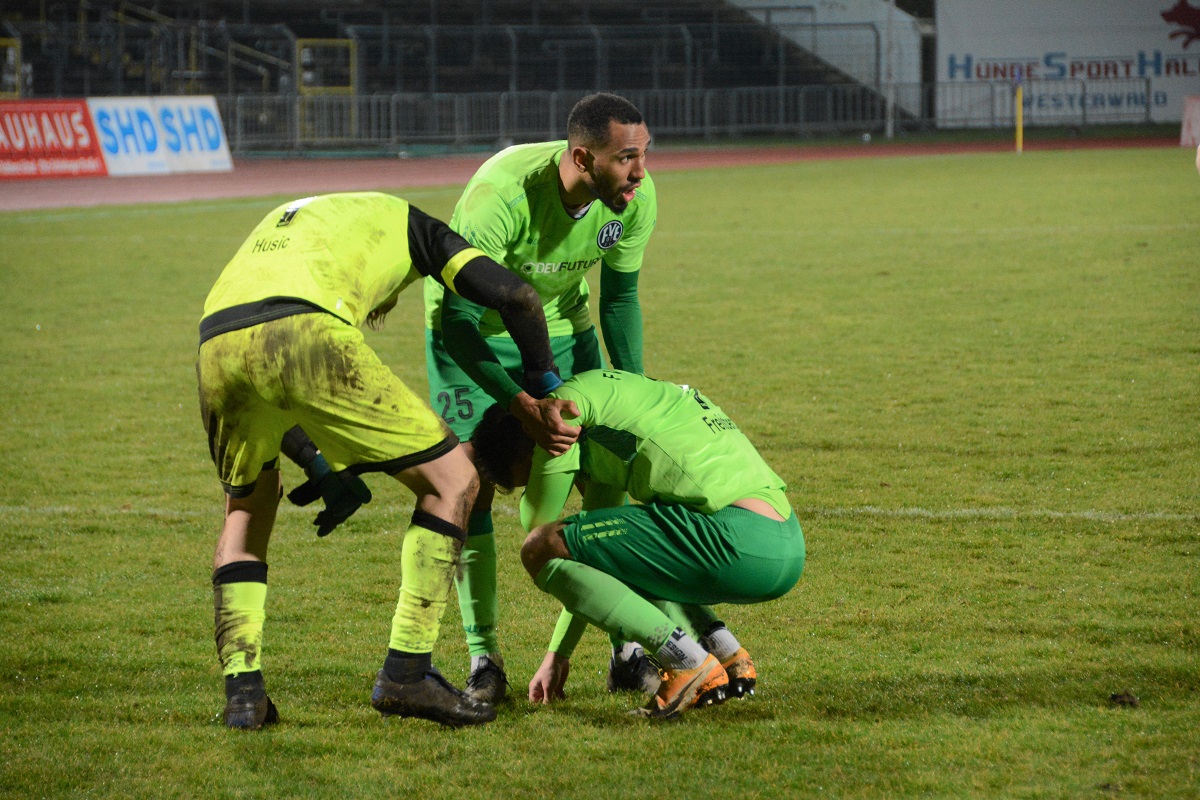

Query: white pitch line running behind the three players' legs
[0,503,1200,525]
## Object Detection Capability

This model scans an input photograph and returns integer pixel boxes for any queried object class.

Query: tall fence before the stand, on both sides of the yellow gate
[0,17,882,97]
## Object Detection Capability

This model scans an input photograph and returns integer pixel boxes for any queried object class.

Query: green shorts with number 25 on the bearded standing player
[425,327,605,440]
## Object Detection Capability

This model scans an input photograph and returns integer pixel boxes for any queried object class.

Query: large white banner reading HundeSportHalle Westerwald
[936,0,1200,127]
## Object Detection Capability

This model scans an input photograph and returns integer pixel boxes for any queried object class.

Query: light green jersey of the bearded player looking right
[425,142,658,337]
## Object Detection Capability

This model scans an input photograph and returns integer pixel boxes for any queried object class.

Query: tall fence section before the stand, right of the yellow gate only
[344,23,881,92]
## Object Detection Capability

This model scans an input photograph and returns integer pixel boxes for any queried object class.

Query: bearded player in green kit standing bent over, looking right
[425,94,658,703]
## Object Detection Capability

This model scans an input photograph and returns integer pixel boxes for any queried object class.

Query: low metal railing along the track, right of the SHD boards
[218,79,1152,154]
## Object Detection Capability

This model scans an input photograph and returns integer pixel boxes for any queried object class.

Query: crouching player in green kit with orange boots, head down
[472,369,804,717]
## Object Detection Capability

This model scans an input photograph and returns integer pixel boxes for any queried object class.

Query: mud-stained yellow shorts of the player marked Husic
[196,313,458,497]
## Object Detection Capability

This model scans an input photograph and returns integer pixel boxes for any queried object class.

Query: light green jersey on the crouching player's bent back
[522,369,791,518]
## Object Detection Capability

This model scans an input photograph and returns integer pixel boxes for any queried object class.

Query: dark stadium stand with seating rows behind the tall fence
[0,0,854,97]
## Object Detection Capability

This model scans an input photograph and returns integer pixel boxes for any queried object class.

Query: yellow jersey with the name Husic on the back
[204,192,421,326]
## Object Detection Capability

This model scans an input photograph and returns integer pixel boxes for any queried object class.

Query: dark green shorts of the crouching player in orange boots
[563,503,804,606]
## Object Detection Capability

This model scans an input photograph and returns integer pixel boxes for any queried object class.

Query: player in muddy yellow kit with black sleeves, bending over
[197,192,577,729]
